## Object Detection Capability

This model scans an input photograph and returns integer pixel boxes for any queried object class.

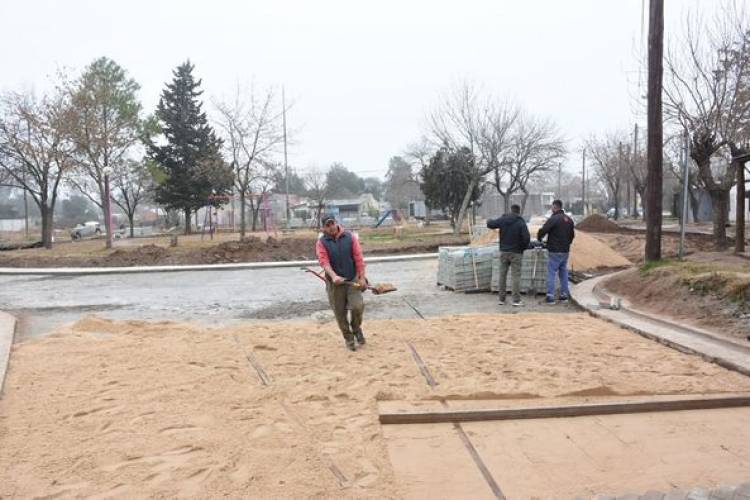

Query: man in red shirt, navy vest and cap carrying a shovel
[315,215,367,351]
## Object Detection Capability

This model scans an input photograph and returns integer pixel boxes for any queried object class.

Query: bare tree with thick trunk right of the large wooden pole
[664,0,750,250]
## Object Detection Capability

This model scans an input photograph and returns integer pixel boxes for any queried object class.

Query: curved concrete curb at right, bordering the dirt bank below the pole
[571,271,750,376]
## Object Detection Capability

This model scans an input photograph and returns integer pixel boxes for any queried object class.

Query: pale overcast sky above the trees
[0,0,742,177]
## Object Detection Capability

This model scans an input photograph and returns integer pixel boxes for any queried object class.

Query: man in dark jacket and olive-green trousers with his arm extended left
[487,205,530,307]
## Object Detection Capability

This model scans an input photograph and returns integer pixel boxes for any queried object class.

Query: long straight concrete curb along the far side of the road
[0,253,438,276]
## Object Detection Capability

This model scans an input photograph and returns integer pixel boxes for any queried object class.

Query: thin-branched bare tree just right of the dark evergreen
[215,86,284,238]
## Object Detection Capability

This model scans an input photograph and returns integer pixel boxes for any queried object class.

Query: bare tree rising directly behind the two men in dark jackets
[494,113,567,213]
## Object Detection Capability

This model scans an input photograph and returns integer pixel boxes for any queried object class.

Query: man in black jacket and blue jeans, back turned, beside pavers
[537,200,576,304]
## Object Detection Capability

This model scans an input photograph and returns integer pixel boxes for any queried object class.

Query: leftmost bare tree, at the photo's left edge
[0,89,73,248]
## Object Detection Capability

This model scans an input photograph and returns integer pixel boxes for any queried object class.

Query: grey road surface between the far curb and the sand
[0,260,574,341]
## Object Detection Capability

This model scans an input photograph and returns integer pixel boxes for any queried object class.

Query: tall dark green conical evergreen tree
[148,61,233,234]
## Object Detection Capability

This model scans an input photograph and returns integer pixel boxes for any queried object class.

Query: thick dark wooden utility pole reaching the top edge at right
[645,0,664,262]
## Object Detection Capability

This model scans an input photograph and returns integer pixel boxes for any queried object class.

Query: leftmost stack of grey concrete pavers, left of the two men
[437,245,498,292]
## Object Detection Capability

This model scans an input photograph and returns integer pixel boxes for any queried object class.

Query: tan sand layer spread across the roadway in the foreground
[0,314,750,498]
